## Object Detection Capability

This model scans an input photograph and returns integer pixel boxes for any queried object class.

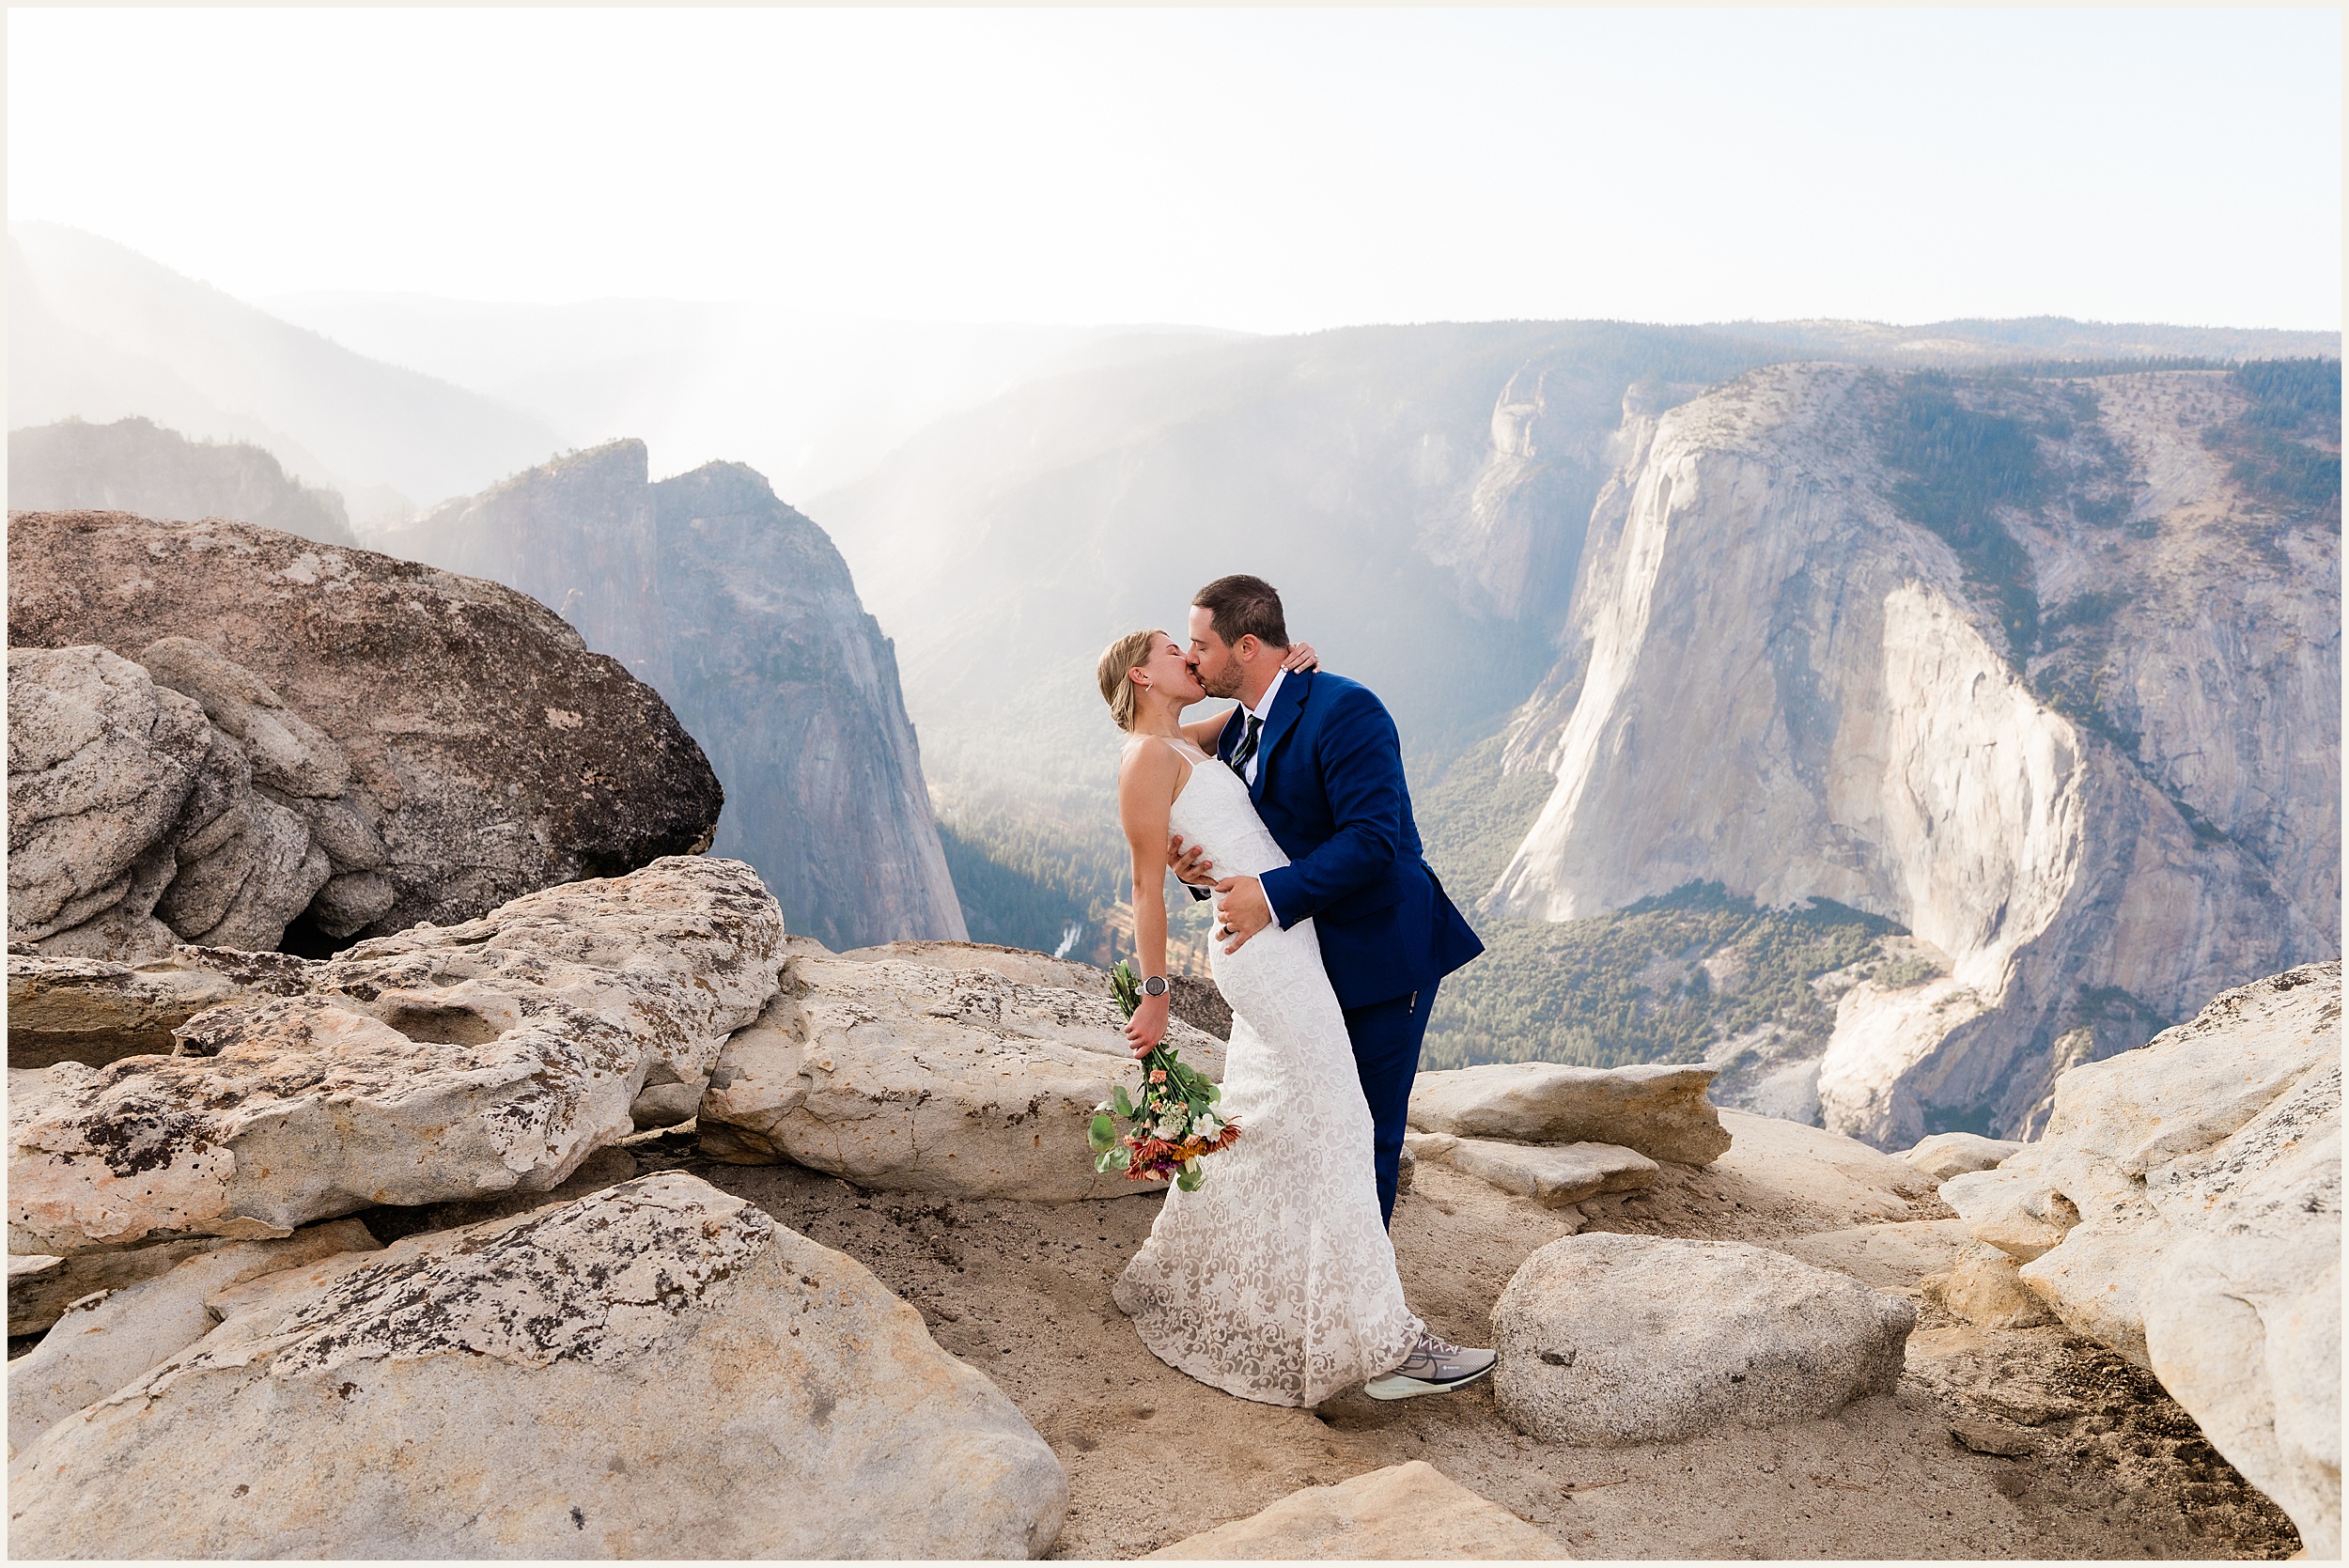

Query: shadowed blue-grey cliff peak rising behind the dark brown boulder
[383,442,966,948]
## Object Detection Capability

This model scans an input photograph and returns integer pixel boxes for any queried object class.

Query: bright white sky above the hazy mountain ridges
[8,9,2342,331]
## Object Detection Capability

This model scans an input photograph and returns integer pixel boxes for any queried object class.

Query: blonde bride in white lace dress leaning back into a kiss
[1097,631,1419,1406]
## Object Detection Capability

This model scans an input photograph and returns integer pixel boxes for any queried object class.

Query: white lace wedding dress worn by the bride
[1113,761,1422,1406]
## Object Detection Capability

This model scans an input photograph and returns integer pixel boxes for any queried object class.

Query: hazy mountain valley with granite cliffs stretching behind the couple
[12,227,2340,1145]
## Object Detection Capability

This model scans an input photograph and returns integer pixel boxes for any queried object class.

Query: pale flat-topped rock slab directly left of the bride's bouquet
[698,953,1245,1202]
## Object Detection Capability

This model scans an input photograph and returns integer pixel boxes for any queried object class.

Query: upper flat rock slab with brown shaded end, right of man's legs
[1409,1061,1729,1164]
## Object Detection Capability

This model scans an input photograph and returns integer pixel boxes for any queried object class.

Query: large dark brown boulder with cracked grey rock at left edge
[9,512,722,957]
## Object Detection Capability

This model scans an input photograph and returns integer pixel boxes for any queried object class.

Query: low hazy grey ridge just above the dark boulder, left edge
[8,418,357,545]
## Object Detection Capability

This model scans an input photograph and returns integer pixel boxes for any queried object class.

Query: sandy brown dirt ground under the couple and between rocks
[597,1115,2300,1559]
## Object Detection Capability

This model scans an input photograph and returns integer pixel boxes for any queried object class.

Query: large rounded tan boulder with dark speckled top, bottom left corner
[9,1172,1069,1559]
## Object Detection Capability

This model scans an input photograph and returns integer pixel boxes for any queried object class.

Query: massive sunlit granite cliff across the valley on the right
[1487,366,2340,1143]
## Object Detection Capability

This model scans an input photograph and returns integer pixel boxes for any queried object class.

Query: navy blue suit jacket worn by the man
[1215,669,1485,1007]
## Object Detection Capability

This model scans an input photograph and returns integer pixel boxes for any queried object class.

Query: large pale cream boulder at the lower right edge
[1943,962,2342,1557]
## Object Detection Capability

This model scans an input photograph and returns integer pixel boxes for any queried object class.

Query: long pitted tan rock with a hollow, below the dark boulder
[8,857,783,1256]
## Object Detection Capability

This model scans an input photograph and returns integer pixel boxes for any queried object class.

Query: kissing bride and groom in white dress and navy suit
[1097,575,1494,1406]
